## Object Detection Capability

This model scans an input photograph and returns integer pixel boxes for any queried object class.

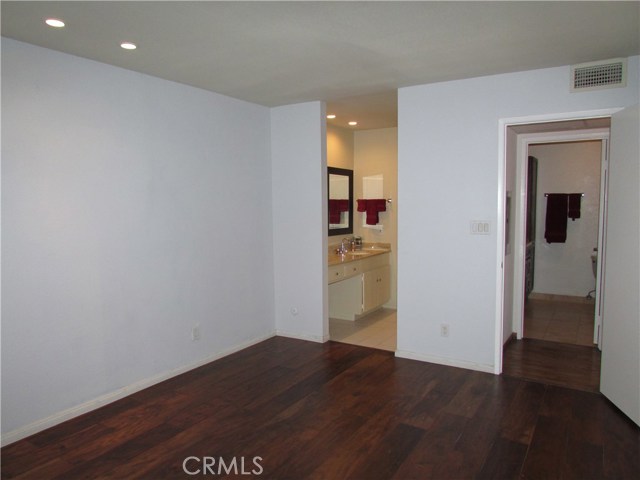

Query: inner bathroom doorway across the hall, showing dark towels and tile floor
[522,139,603,346]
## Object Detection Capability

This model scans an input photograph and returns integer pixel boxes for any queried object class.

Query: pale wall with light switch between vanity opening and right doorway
[398,57,638,371]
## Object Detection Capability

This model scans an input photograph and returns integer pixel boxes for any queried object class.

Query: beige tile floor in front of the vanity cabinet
[329,308,397,352]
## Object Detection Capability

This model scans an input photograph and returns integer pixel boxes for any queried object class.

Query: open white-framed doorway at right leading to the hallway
[503,118,609,391]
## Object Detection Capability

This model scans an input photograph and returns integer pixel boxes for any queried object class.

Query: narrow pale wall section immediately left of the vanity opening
[272,102,329,341]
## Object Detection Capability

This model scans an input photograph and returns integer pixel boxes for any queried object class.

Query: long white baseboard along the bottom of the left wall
[2,332,276,447]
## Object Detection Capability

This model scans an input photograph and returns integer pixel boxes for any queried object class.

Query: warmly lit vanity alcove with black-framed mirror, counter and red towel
[325,124,398,352]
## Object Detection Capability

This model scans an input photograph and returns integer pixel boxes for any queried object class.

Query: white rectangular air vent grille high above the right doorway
[571,58,627,92]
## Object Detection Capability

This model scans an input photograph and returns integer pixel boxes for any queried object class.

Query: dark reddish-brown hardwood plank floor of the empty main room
[2,337,640,480]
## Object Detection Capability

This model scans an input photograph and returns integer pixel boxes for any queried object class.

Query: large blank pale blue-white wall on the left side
[2,38,272,439]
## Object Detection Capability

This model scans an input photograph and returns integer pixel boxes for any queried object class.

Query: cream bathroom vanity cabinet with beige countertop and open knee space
[328,245,391,320]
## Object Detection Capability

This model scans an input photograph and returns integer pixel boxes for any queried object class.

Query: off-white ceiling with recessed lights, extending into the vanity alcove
[1,1,640,128]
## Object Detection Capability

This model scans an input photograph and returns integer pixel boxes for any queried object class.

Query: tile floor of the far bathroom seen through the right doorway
[524,296,595,347]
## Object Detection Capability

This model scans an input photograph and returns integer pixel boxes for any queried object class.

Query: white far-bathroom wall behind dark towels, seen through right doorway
[529,141,602,297]
